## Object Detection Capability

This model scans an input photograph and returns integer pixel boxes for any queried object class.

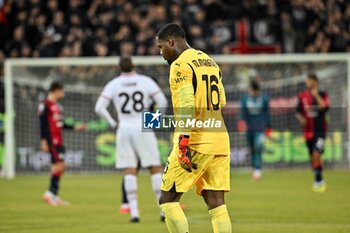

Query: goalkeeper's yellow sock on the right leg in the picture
[209,205,232,233]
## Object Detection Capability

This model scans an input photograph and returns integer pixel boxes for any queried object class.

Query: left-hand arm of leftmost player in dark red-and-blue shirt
[39,103,50,152]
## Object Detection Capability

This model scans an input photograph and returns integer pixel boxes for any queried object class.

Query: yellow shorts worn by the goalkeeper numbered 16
[161,147,230,195]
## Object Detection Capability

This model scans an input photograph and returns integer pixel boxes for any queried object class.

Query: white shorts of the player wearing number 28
[116,127,161,169]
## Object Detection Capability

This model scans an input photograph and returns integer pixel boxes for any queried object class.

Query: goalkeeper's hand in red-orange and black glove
[178,134,198,172]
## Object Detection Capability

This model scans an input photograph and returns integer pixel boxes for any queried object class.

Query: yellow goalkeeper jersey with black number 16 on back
[169,48,230,155]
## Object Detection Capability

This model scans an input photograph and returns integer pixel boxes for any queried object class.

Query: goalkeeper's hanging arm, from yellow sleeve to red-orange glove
[170,63,197,172]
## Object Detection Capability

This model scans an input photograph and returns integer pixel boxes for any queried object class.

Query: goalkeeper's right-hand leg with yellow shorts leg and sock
[196,155,232,233]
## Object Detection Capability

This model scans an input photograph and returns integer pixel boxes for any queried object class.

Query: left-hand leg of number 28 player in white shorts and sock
[116,128,140,222]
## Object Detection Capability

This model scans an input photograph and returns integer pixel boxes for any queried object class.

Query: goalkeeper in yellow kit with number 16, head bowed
[156,23,231,233]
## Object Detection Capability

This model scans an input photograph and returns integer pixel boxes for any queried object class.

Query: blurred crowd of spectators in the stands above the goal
[0,0,350,74]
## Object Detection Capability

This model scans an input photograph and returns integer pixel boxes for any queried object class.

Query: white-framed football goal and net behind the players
[1,55,350,177]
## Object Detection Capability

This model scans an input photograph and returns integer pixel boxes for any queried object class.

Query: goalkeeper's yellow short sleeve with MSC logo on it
[170,63,193,90]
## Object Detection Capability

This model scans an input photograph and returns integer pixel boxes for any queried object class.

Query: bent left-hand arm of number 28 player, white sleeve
[95,83,118,129]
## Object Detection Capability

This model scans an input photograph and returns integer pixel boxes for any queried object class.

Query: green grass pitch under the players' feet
[0,170,350,233]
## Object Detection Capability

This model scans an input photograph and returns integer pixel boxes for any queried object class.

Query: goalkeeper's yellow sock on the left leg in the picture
[160,202,189,233]
